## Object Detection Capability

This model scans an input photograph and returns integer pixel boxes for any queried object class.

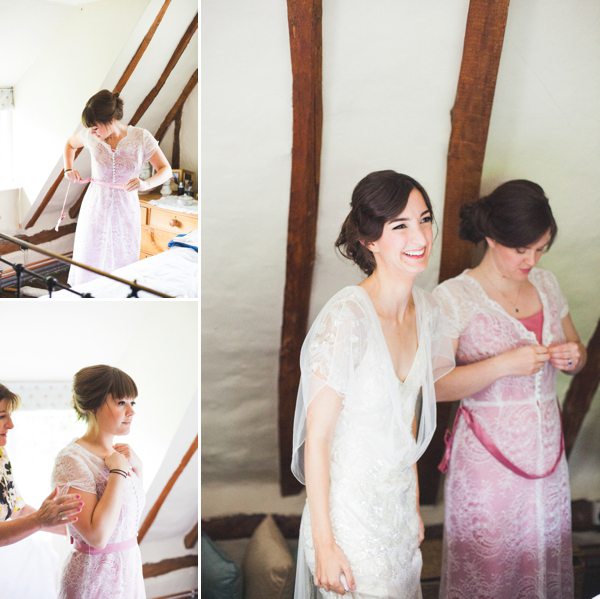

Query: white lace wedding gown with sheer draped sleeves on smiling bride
[293,286,453,599]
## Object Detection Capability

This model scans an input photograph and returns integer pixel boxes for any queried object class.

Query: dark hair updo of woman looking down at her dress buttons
[458,179,558,248]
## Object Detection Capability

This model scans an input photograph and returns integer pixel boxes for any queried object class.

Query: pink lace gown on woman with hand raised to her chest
[52,441,146,599]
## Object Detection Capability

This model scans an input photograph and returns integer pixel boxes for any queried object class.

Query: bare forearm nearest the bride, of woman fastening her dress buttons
[435,339,550,401]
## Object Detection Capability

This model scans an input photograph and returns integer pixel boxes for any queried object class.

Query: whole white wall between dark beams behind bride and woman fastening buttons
[202,0,600,517]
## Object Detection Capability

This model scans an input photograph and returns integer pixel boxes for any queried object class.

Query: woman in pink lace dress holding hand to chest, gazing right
[52,365,146,599]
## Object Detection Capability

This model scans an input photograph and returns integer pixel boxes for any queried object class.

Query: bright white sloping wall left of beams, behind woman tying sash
[14,0,149,211]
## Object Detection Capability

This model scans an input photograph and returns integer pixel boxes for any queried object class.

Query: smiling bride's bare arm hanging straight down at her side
[304,386,355,595]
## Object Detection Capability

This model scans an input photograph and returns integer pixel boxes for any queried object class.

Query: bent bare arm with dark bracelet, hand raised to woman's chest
[69,451,131,549]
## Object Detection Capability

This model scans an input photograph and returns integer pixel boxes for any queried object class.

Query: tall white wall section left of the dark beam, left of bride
[201,0,292,492]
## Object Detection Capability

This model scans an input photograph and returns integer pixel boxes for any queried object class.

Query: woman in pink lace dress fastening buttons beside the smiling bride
[434,180,586,599]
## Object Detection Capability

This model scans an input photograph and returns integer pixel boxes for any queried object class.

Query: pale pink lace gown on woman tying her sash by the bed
[68,126,158,287]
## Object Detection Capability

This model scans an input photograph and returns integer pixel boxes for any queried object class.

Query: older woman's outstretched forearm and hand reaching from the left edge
[0,489,83,547]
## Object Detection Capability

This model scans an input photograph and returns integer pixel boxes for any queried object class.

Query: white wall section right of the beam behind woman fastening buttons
[482,0,600,500]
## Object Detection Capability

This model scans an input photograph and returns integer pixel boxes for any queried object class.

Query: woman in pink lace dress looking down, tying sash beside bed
[64,89,172,286]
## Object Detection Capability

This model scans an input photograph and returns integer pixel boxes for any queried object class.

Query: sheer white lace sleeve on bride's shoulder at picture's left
[292,290,366,484]
